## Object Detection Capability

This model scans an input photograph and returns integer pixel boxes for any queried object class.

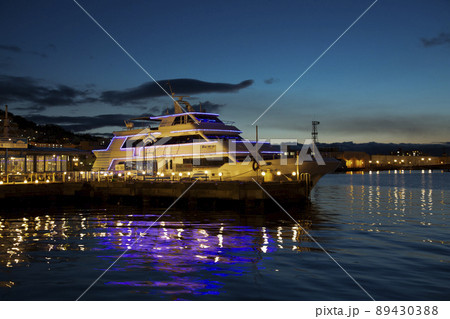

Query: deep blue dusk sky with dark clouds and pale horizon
[0,0,450,143]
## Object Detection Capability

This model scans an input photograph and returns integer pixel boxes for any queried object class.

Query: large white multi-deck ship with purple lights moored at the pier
[93,96,339,186]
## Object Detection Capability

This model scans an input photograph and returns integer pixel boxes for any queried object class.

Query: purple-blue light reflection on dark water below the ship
[89,221,277,295]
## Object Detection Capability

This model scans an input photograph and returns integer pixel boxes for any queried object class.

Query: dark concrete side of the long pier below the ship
[0,181,310,209]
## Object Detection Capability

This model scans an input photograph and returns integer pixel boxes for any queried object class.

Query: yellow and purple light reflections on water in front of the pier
[0,208,320,294]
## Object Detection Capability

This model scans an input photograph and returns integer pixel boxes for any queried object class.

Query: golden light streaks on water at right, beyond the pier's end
[313,170,450,242]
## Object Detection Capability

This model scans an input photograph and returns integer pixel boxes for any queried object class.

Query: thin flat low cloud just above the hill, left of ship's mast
[26,114,152,132]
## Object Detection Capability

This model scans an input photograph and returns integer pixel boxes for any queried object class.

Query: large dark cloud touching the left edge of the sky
[0,75,90,110]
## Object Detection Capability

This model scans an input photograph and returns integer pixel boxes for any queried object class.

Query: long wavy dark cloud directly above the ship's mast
[100,79,253,105]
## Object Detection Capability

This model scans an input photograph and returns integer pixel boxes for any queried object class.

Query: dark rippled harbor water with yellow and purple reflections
[0,170,450,300]
